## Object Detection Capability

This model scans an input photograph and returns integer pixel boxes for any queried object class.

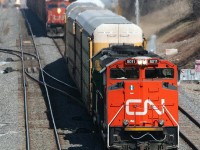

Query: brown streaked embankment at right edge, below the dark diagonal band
[158,16,200,68]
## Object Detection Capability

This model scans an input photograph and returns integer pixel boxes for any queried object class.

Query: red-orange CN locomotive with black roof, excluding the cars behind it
[92,46,179,150]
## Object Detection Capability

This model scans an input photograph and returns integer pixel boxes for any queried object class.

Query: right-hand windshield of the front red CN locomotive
[145,68,174,79]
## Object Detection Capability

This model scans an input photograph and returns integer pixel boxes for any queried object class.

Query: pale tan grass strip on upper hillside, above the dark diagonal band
[140,0,192,38]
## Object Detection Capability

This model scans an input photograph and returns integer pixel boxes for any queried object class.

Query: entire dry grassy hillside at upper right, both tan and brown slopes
[138,0,200,68]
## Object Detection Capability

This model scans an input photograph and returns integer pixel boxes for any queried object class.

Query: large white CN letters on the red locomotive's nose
[126,99,165,116]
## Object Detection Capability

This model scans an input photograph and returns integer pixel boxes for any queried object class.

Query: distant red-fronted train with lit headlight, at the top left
[27,0,73,37]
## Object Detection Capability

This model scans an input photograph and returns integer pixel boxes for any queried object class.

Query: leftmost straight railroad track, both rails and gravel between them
[19,11,61,150]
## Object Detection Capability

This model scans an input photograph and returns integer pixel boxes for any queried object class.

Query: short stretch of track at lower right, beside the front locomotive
[179,106,200,150]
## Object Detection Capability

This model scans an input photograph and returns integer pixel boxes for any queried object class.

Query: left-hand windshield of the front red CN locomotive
[110,68,139,79]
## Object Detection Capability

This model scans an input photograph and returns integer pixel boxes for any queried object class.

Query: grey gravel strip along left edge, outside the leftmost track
[0,1,20,150]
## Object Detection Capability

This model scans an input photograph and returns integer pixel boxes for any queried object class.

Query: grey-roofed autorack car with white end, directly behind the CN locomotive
[67,5,143,110]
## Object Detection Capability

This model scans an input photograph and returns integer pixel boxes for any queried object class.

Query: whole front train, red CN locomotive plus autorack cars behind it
[65,2,179,150]
